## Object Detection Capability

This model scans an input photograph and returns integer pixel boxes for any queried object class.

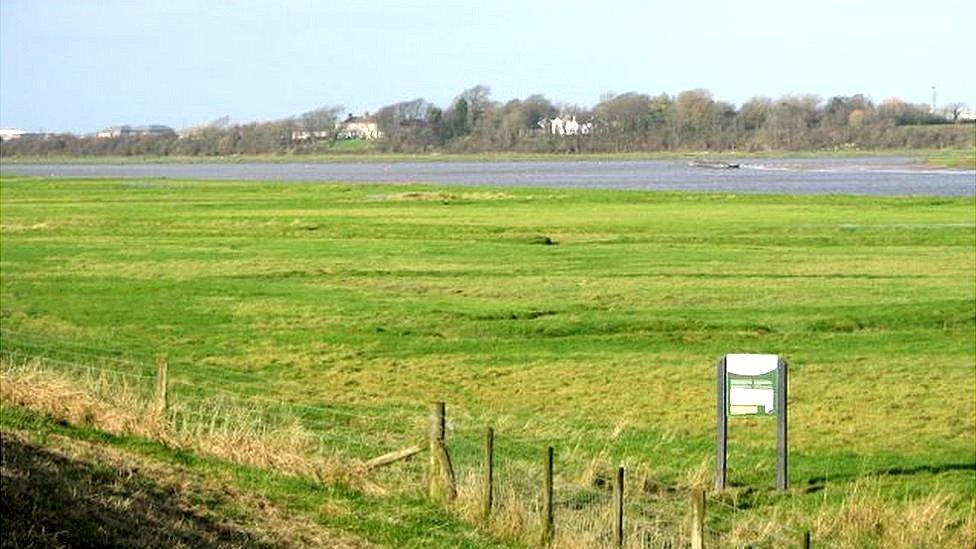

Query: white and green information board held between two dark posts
[725,354,779,416]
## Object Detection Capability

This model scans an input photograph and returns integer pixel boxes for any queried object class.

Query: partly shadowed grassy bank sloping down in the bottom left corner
[0,405,506,549]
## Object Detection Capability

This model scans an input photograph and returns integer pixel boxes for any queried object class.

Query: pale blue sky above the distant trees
[0,0,976,133]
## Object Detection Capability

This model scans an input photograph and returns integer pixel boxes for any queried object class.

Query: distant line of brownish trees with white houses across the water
[0,86,976,157]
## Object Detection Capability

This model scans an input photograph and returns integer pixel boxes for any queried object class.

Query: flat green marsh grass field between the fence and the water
[0,177,976,547]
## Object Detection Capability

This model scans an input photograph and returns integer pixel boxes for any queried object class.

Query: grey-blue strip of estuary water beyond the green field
[0,156,976,196]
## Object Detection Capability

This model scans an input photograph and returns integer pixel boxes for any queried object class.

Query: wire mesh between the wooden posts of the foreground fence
[0,330,825,547]
